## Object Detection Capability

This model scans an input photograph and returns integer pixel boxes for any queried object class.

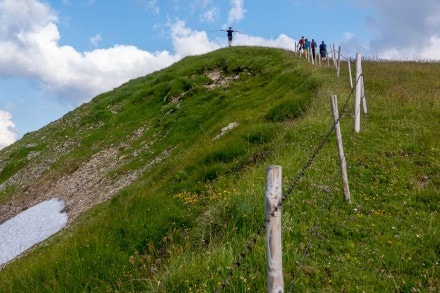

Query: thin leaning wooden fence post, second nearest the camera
[330,95,351,203]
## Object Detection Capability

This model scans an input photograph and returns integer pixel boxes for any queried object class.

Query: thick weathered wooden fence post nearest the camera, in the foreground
[265,165,284,293]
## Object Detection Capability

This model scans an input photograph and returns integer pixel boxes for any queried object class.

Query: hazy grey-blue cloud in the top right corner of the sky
[360,0,440,59]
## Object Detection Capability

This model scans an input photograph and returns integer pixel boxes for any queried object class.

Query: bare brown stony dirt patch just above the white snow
[0,125,172,224]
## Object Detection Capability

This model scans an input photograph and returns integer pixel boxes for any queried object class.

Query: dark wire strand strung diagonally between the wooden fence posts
[215,62,362,292]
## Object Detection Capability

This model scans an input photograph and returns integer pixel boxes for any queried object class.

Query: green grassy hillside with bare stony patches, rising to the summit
[0,47,440,292]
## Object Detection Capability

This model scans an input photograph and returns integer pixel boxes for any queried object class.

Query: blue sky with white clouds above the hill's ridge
[0,0,440,149]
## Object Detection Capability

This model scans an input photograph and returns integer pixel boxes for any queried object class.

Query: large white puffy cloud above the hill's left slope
[0,0,177,105]
